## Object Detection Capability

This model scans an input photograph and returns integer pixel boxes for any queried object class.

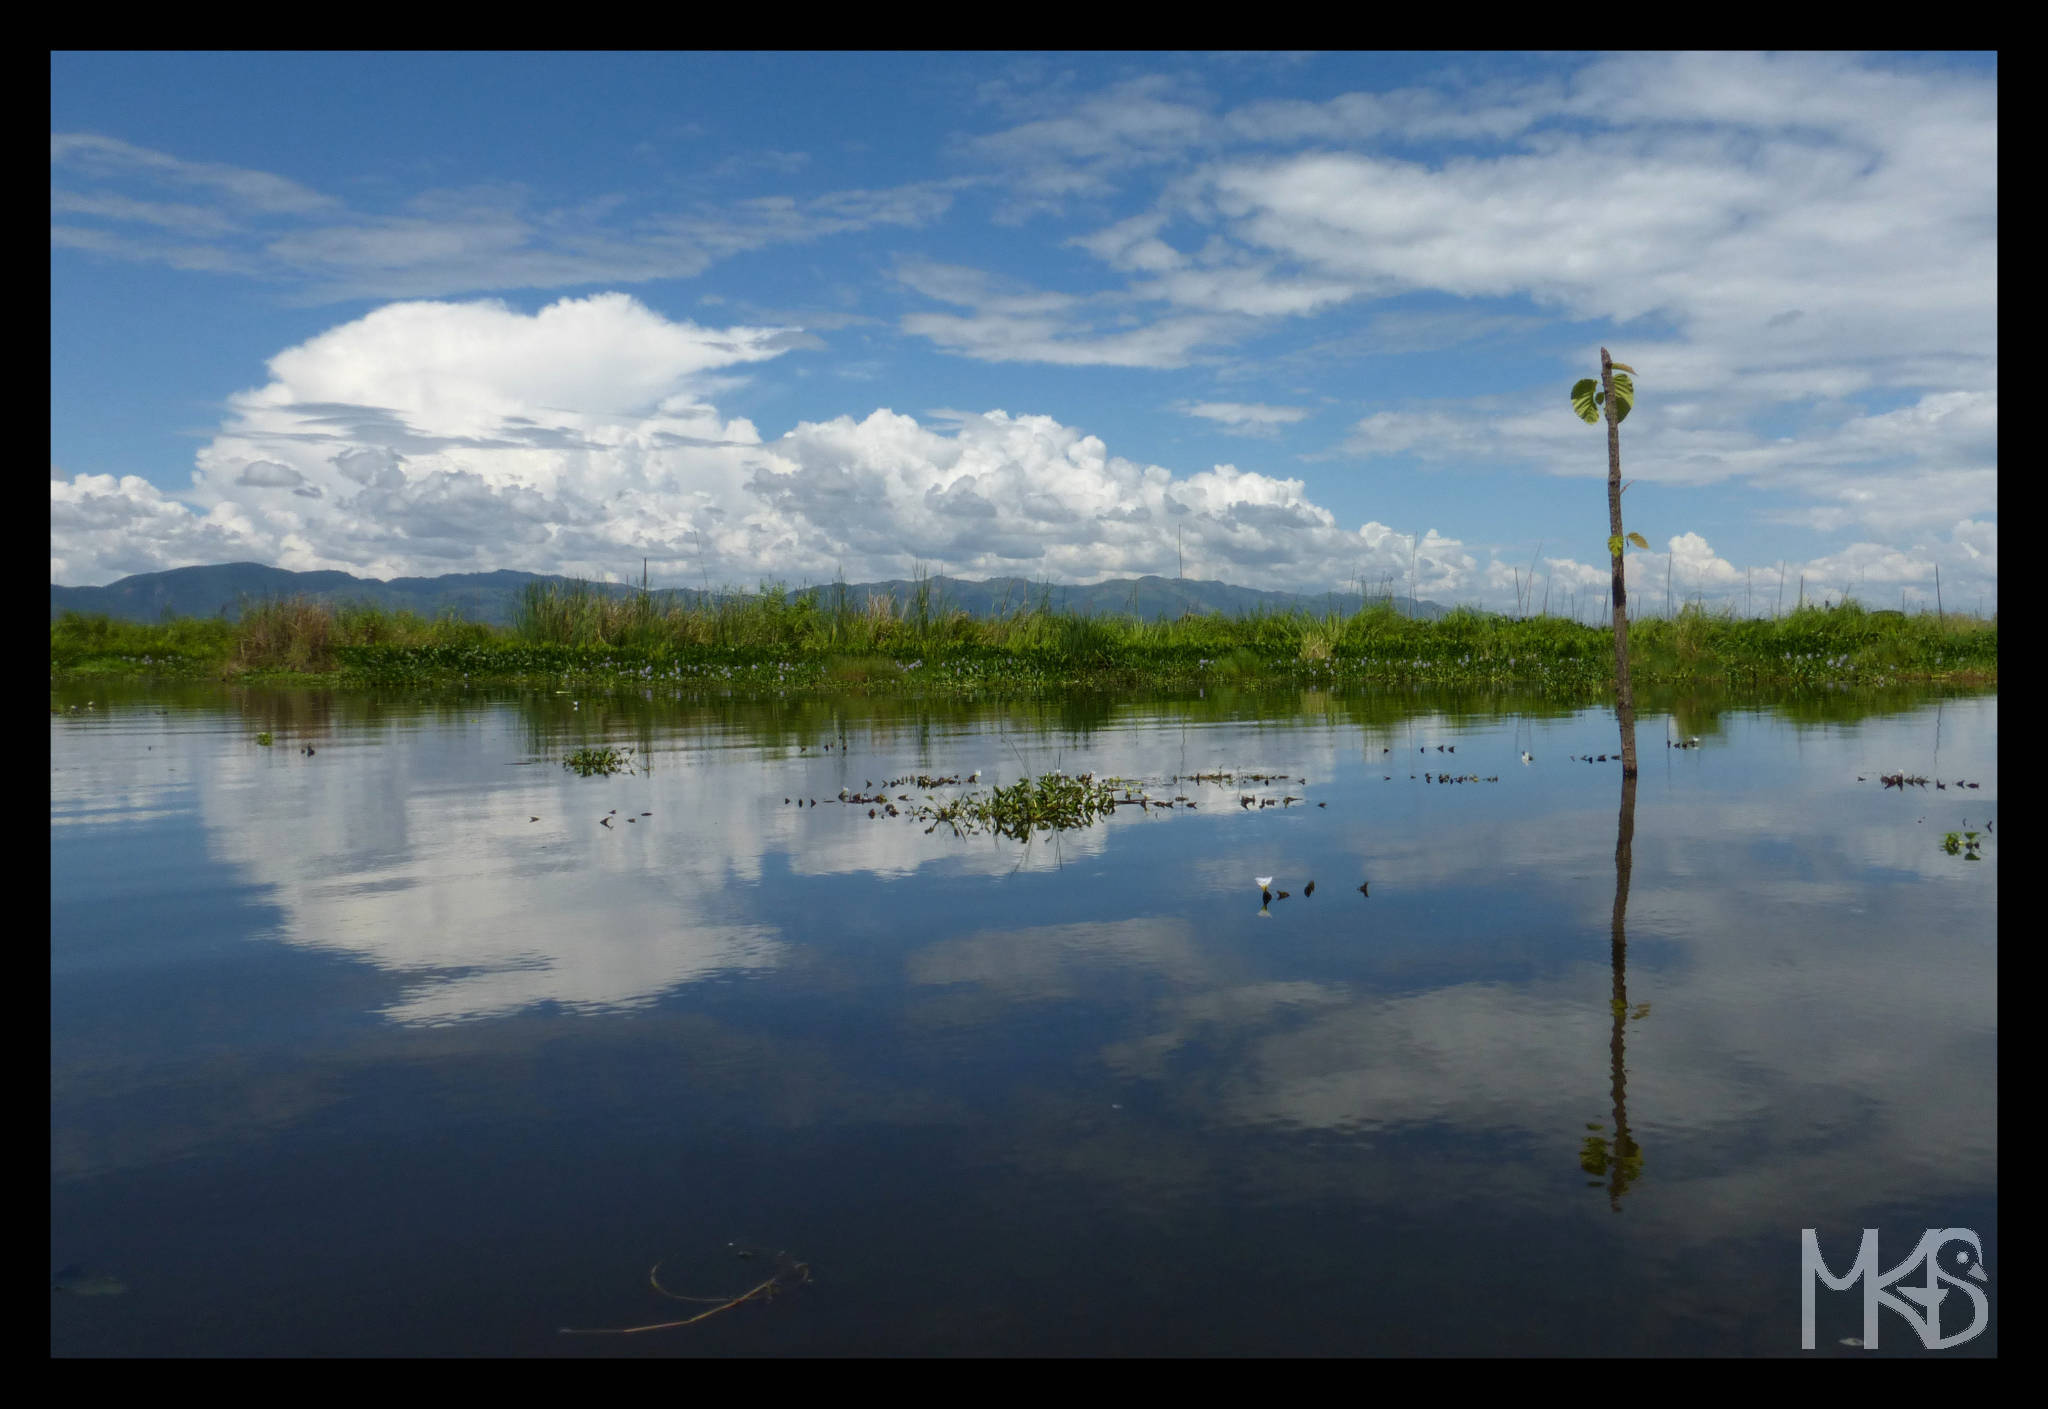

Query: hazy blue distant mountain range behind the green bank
[49,563,1448,627]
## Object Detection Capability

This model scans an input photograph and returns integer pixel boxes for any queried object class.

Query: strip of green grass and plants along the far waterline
[49,586,1999,694]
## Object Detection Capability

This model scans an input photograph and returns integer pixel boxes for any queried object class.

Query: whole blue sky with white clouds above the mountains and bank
[51,53,1999,616]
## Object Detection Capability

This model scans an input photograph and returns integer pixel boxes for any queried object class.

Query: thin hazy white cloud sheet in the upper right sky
[966,53,1997,423]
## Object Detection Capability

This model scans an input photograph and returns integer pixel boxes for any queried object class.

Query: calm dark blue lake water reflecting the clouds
[49,684,2001,1356]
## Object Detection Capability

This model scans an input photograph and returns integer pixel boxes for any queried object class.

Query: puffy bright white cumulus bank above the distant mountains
[51,293,1477,592]
